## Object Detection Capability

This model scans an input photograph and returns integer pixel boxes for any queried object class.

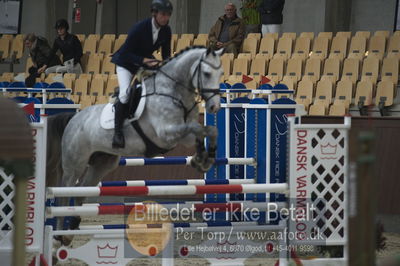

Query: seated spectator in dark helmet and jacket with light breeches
[40,19,82,75]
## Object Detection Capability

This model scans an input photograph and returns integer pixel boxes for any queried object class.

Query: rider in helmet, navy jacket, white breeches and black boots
[111,0,173,148]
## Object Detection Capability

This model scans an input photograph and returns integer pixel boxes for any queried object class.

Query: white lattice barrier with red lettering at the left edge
[0,117,47,265]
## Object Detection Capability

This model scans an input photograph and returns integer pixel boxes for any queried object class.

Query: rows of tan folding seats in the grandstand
[0,31,400,116]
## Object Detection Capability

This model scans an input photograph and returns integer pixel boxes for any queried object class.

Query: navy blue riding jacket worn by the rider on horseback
[111,18,171,74]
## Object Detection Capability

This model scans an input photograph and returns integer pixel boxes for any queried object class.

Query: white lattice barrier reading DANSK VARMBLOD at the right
[289,117,350,265]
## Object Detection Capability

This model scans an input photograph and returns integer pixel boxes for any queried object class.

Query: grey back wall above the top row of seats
[16,0,396,39]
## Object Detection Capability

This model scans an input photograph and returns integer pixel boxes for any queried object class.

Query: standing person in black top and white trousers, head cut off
[258,0,285,34]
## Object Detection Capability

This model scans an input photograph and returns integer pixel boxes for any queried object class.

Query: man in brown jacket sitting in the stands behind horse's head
[208,3,245,56]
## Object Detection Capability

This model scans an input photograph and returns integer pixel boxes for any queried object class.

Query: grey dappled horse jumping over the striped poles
[47,47,223,244]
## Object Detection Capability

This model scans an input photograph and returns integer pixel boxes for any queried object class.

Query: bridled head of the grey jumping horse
[190,49,223,113]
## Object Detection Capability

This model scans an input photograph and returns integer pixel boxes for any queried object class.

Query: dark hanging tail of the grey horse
[46,113,76,186]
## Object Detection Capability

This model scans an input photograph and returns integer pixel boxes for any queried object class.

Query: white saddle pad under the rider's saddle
[100,83,146,129]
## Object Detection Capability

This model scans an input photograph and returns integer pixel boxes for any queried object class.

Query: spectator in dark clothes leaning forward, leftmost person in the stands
[24,33,61,87]
